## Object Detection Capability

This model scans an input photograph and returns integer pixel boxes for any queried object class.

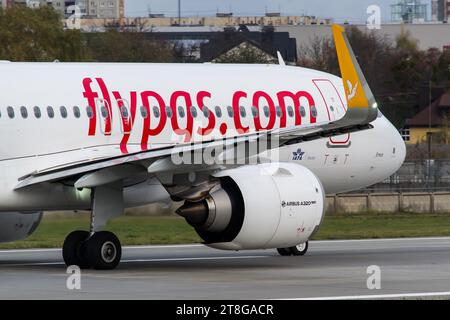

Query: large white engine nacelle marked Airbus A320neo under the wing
[177,163,325,250]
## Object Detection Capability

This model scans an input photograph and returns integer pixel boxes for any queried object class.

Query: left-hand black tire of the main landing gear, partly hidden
[63,231,90,269]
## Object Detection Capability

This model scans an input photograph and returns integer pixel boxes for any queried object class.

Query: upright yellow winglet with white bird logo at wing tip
[332,24,378,123]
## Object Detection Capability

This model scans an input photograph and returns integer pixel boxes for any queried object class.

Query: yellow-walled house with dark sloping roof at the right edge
[401,91,450,144]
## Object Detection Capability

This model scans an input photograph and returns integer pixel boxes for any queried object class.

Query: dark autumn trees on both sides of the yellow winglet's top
[298,26,450,128]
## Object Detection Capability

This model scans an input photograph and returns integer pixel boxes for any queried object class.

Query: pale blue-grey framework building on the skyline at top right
[391,0,427,23]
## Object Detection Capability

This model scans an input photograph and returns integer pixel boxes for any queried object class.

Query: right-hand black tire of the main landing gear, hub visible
[86,231,122,270]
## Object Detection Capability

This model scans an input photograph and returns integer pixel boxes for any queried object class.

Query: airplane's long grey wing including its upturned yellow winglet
[16,25,378,189]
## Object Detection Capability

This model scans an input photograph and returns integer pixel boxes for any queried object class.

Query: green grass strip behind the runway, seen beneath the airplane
[0,213,450,249]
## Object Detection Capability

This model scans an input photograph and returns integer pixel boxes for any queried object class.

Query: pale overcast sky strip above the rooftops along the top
[125,0,431,22]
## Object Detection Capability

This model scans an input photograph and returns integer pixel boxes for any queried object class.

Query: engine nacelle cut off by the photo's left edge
[0,212,42,243]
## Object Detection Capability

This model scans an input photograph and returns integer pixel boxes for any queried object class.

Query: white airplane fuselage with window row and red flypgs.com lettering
[0,63,405,211]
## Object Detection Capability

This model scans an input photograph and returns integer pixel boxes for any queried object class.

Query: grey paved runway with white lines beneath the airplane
[0,238,450,300]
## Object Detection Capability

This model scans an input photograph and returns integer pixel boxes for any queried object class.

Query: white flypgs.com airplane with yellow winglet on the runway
[0,26,405,269]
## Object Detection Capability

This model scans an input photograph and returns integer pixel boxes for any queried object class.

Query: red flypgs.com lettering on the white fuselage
[83,77,316,153]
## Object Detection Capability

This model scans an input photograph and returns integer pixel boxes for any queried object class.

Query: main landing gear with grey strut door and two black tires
[63,185,123,270]
